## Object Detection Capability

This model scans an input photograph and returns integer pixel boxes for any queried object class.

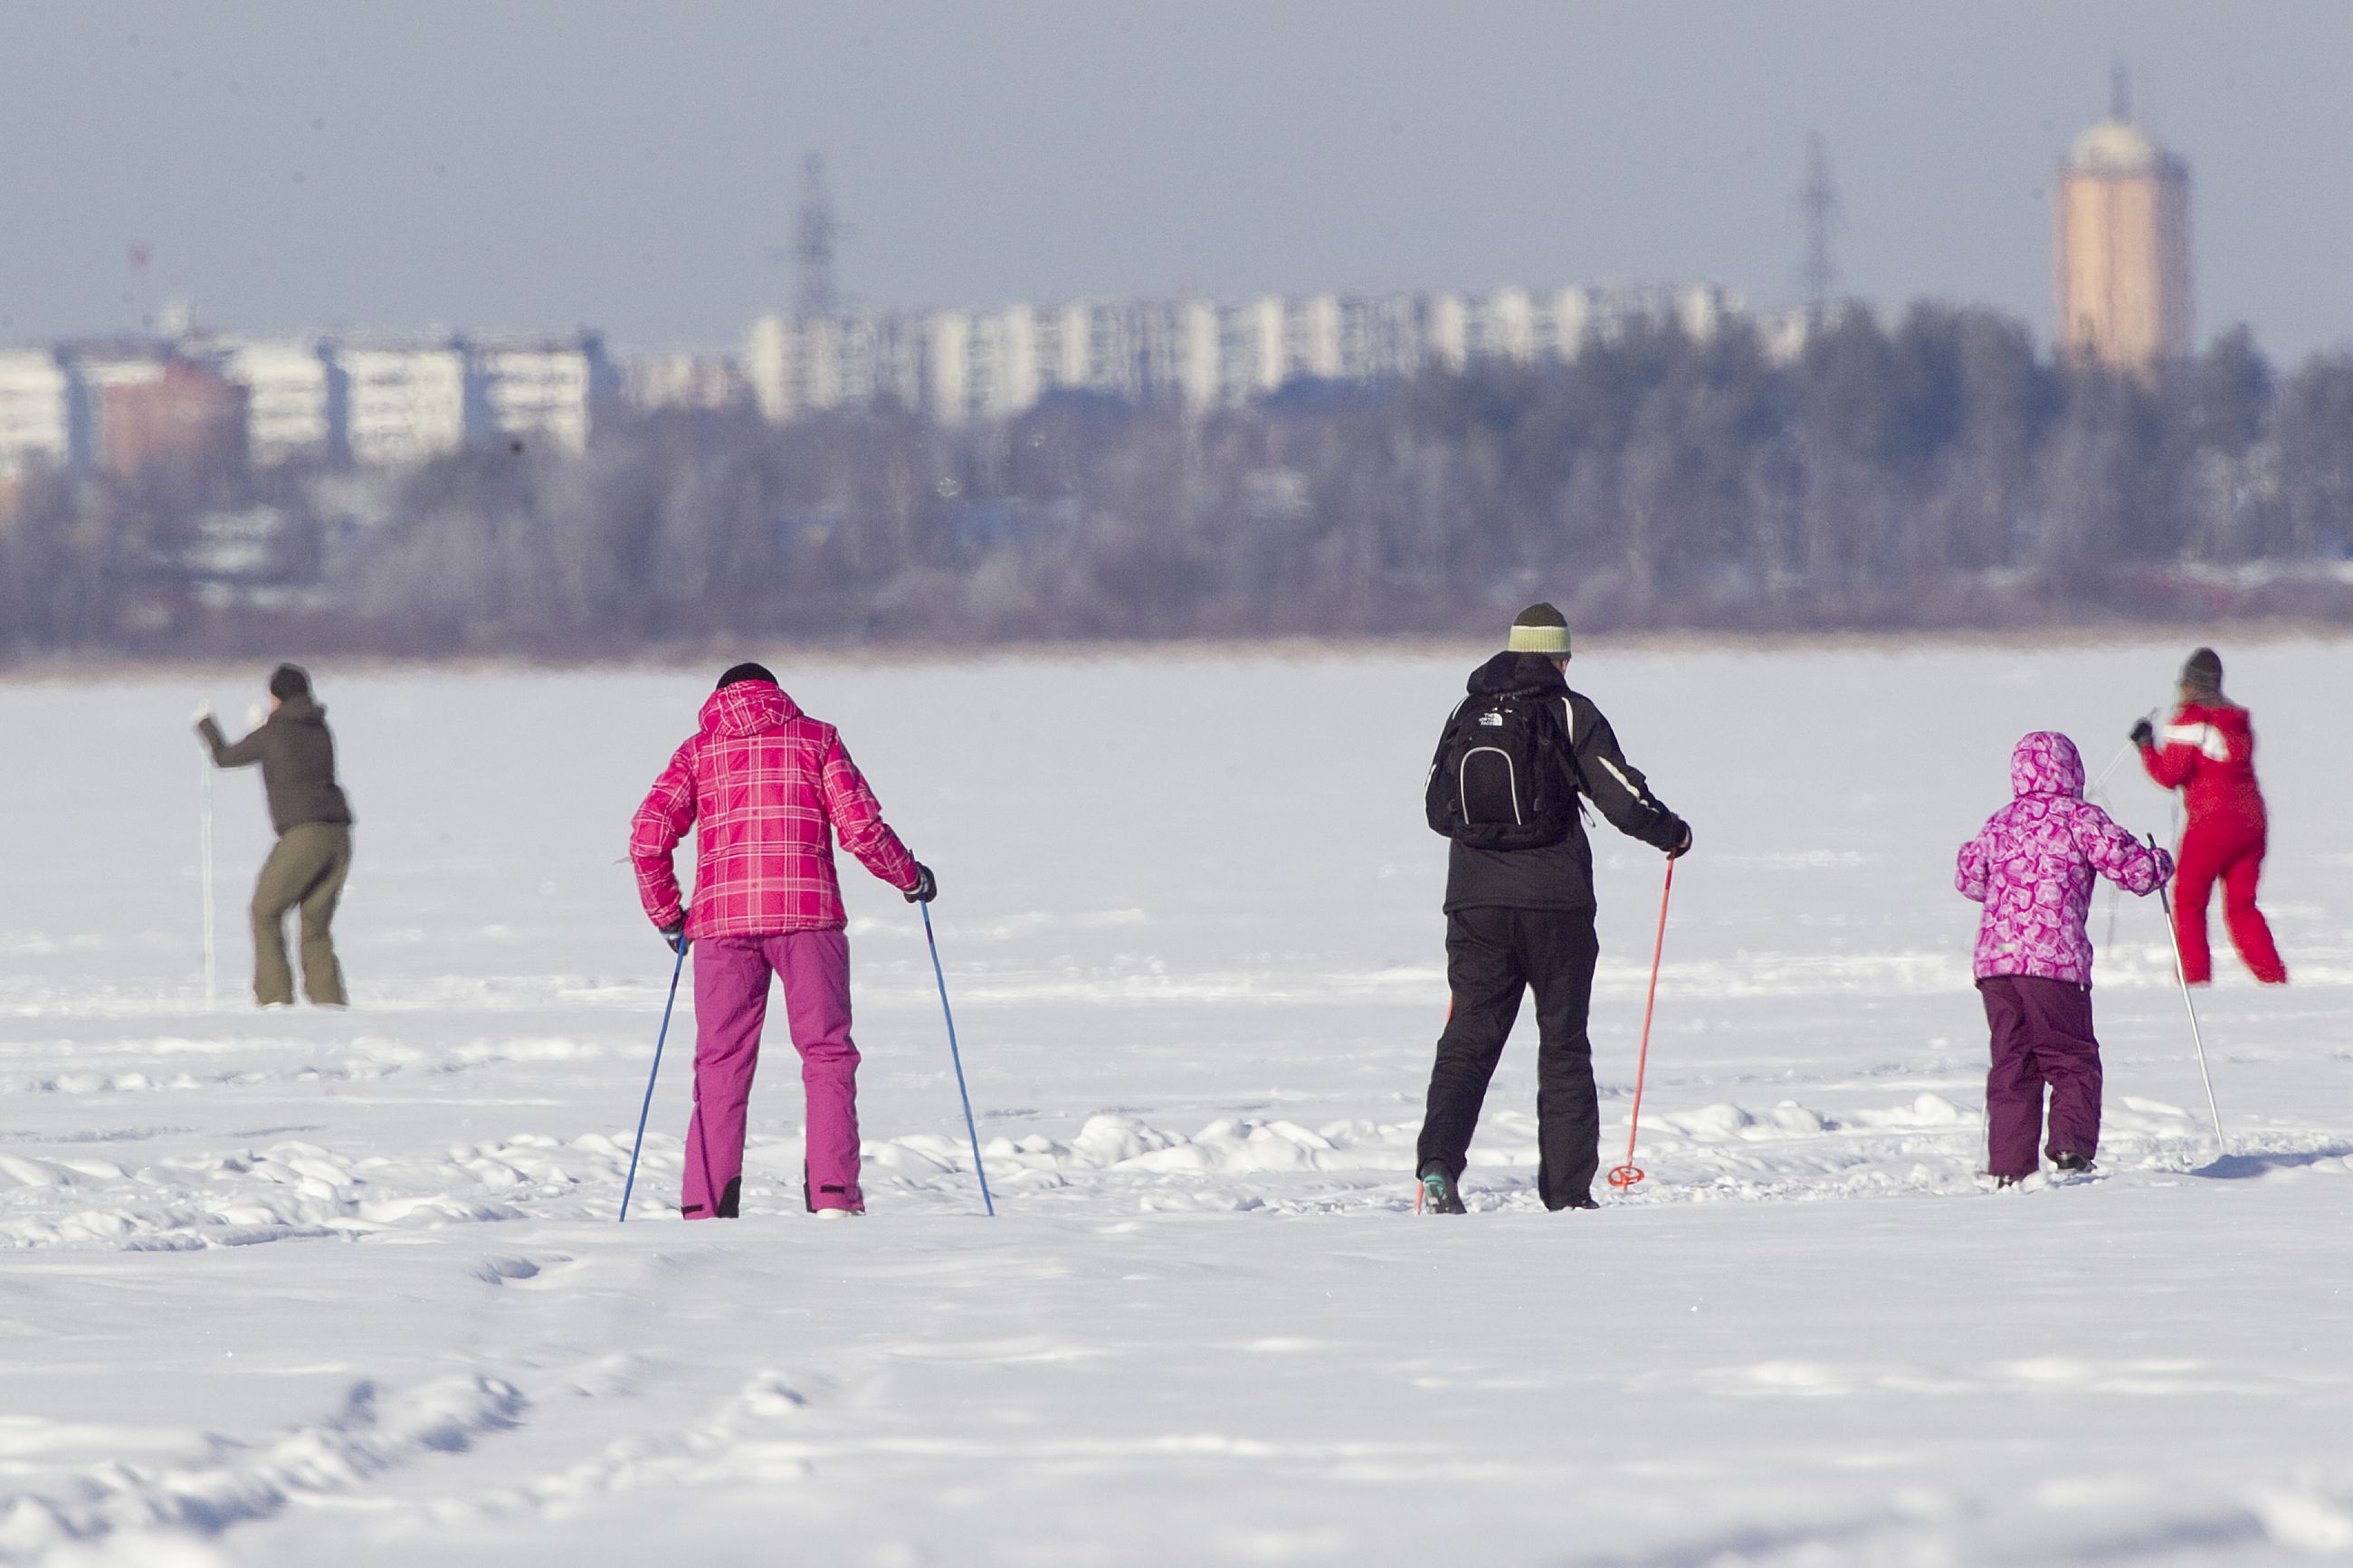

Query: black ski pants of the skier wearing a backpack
[1415,910,1600,1208]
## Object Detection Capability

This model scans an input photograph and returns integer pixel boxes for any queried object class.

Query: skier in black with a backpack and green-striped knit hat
[1415,604,1691,1213]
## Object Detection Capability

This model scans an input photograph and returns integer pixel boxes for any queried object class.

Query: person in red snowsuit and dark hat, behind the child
[2132,649,2287,985]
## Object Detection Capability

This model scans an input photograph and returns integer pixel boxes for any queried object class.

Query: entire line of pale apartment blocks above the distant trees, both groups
[0,284,1759,482]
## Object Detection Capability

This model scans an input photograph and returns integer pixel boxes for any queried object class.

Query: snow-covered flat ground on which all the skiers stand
[0,644,2353,1568]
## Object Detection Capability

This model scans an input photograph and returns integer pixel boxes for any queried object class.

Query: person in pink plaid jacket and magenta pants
[628,663,937,1220]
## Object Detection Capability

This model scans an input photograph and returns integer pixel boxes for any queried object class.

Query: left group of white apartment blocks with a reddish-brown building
[0,331,619,480]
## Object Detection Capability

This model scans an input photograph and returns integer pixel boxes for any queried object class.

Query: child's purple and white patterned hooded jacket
[1953,728,2174,985]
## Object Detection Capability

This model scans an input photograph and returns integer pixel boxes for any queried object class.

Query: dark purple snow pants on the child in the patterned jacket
[1977,975,2099,1175]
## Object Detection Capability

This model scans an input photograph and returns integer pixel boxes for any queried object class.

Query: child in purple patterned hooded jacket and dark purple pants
[1953,731,2174,1187]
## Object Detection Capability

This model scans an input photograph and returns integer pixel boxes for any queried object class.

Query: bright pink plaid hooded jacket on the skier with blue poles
[628,679,915,940]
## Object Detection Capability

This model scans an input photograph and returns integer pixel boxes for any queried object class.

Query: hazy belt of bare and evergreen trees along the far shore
[0,306,2353,656]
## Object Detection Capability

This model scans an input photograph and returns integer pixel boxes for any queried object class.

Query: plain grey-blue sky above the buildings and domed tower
[0,0,2353,355]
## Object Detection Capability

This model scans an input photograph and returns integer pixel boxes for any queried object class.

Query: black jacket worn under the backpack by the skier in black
[1431,653,1690,915]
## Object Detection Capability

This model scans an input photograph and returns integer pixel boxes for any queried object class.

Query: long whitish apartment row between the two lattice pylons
[743,284,1759,425]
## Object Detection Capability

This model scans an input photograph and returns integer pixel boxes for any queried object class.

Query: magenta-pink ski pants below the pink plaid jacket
[680,927,866,1220]
